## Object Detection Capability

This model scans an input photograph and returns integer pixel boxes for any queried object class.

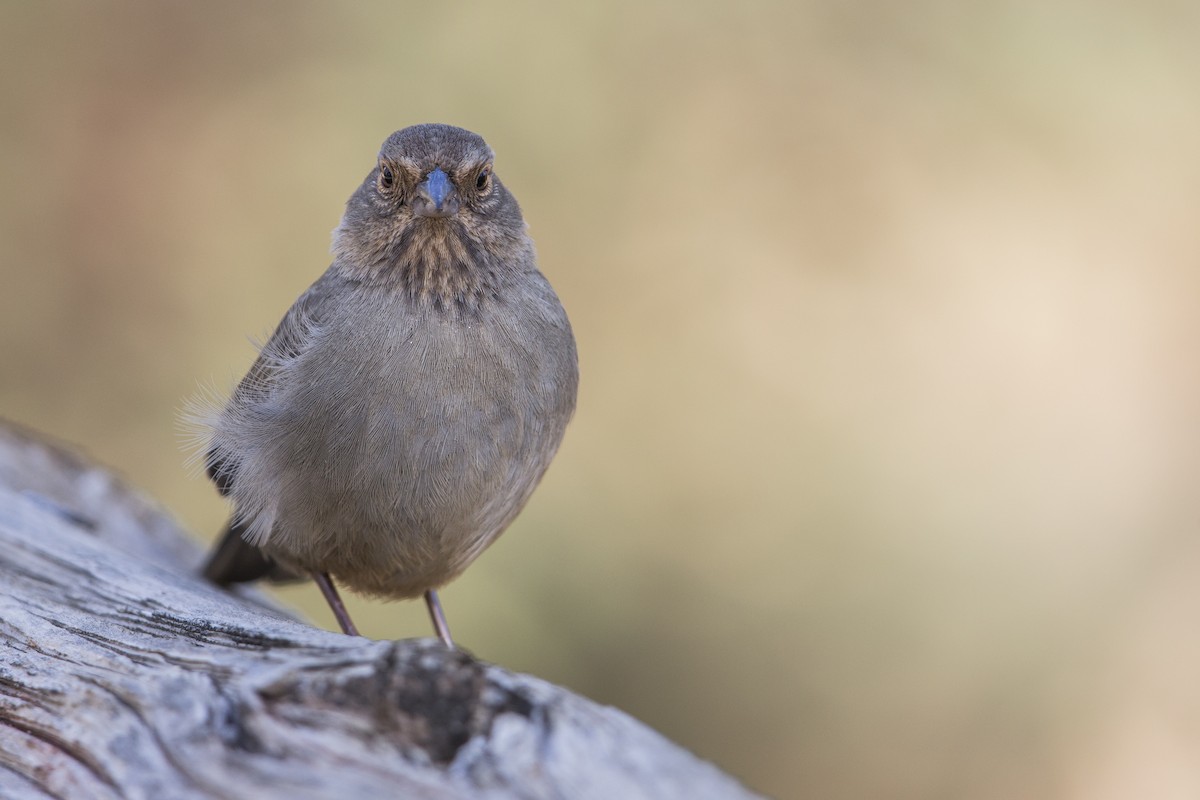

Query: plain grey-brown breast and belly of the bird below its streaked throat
[232,276,577,596]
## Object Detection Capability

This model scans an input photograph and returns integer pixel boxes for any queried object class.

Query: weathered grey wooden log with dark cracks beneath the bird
[0,423,754,800]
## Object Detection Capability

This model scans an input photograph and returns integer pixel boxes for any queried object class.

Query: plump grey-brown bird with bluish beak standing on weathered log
[194,124,578,648]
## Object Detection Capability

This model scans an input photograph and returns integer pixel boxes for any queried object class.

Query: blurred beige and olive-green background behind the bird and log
[0,0,1200,800]
